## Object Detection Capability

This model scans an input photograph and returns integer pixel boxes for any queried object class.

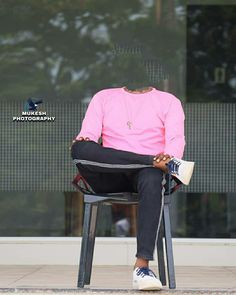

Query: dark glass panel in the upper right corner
[187,5,236,102]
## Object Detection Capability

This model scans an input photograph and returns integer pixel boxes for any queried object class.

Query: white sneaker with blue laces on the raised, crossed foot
[167,158,194,185]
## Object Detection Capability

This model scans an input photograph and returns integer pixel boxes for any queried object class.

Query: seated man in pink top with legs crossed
[71,83,193,290]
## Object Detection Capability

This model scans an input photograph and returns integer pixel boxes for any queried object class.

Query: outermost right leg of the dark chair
[163,203,176,289]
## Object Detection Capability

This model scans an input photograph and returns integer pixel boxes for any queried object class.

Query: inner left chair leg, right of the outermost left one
[85,203,100,285]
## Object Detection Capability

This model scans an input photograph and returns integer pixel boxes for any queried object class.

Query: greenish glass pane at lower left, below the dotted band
[0,191,65,237]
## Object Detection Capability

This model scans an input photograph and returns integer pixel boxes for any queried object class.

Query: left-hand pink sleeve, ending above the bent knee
[76,92,103,142]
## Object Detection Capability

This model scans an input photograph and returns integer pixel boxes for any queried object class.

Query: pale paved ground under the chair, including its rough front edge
[0,265,236,295]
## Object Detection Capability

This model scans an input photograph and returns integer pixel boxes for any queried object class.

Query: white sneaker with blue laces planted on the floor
[133,267,162,290]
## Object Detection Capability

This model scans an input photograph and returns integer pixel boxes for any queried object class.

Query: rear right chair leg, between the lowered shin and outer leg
[157,220,166,286]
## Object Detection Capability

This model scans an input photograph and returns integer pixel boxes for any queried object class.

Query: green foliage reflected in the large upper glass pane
[0,0,185,101]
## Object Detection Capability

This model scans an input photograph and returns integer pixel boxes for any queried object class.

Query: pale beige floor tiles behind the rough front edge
[0,265,236,295]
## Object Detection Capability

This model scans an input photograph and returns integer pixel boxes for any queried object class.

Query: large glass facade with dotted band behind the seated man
[0,0,236,238]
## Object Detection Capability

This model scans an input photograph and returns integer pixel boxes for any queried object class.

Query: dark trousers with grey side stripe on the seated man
[71,141,164,260]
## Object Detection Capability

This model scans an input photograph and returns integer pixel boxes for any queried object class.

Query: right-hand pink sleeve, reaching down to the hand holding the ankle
[164,97,185,158]
